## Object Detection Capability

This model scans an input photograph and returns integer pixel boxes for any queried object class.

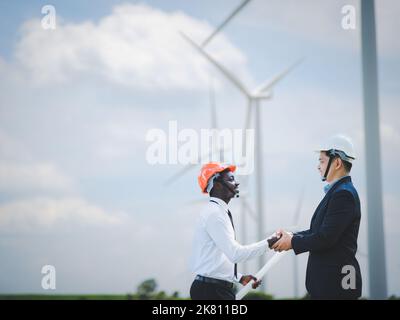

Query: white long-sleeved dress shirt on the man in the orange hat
[191,197,268,282]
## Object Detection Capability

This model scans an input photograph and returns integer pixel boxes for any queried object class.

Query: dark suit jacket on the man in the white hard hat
[292,176,362,299]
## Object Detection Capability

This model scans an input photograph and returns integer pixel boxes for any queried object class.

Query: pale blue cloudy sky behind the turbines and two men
[0,0,400,298]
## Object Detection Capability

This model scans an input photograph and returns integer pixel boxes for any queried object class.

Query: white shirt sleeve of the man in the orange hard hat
[206,213,268,263]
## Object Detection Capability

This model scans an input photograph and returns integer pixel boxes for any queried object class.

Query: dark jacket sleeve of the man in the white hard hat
[292,191,355,254]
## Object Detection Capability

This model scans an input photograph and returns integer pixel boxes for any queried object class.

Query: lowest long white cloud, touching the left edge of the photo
[0,197,124,233]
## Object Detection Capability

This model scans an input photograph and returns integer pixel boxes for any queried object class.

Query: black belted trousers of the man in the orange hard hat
[190,280,235,300]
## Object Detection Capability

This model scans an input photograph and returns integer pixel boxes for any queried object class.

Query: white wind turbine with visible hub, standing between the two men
[181,32,303,288]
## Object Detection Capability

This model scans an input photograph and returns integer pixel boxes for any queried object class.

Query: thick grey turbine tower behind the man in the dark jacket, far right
[360,0,387,299]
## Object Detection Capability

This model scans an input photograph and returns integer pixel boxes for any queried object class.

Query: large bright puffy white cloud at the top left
[16,4,250,90]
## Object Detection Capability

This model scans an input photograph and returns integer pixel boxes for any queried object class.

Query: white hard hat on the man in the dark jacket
[316,134,356,163]
